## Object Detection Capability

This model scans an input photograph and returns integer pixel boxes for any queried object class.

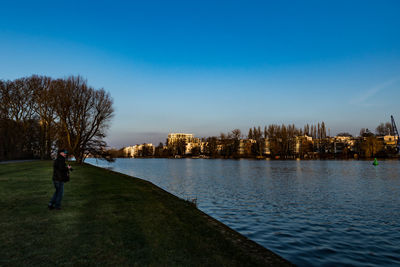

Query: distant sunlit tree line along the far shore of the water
[122,122,397,159]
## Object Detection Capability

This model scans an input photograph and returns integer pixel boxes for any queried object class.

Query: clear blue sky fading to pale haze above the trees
[0,0,400,147]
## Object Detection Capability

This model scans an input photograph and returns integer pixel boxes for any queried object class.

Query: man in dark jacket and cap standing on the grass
[48,149,71,210]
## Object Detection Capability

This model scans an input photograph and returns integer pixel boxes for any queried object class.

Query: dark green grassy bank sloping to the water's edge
[0,161,290,266]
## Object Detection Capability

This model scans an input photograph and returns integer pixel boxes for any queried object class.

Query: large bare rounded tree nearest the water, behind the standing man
[55,76,114,163]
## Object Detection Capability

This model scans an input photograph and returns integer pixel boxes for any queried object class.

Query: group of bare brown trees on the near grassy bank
[0,75,114,163]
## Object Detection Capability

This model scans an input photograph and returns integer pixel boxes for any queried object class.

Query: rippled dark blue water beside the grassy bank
[87,159,400,266]
